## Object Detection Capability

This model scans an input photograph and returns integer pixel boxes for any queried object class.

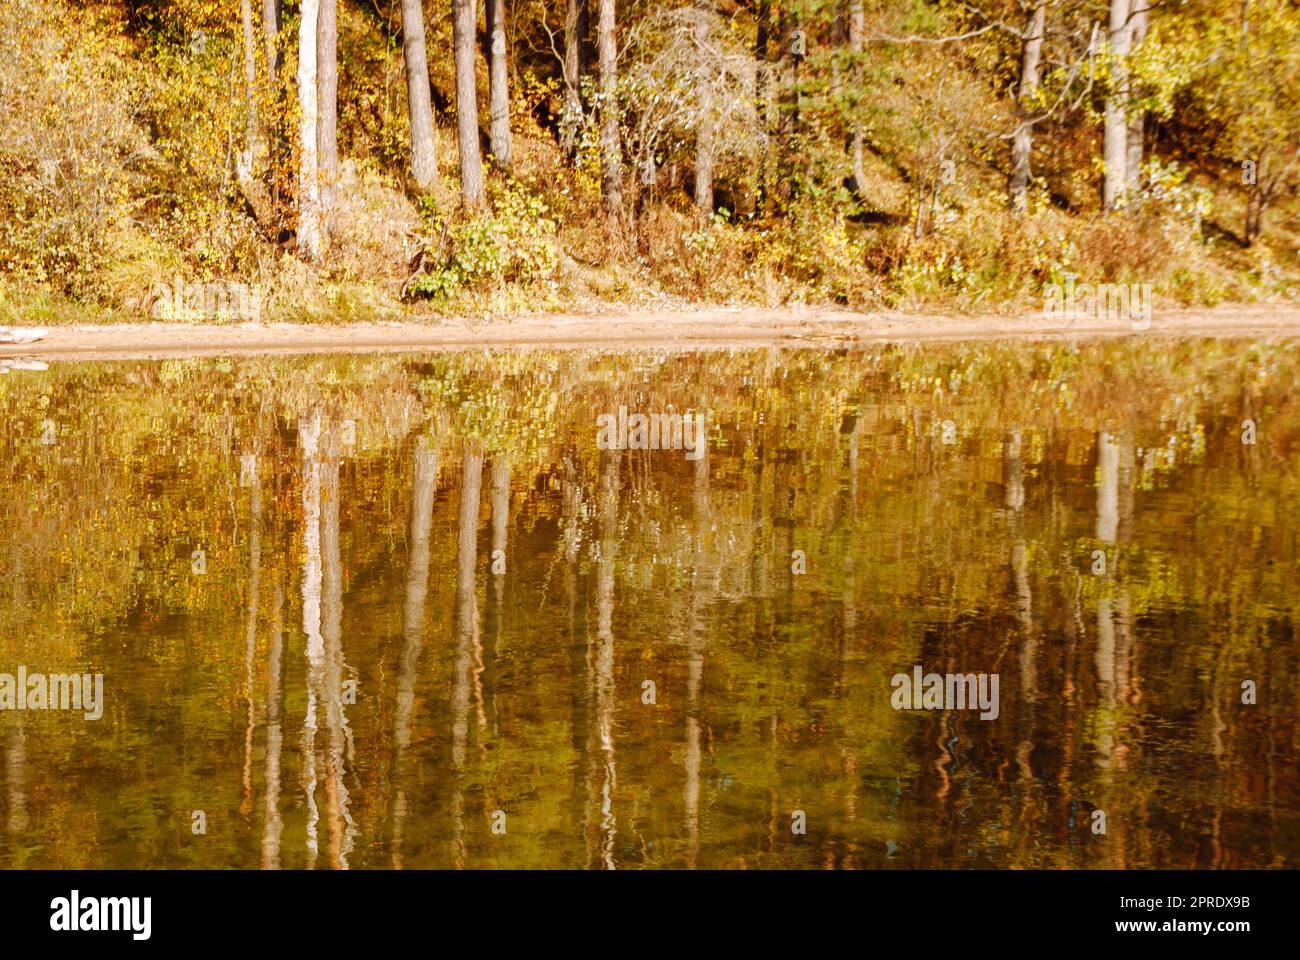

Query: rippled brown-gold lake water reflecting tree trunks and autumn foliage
[0,338,1300,869]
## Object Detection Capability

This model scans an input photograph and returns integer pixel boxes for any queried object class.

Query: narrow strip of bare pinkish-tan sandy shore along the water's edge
[0,304,1300,360]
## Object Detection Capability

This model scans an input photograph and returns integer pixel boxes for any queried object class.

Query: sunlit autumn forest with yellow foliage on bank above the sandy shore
[0,0,1300,323]
